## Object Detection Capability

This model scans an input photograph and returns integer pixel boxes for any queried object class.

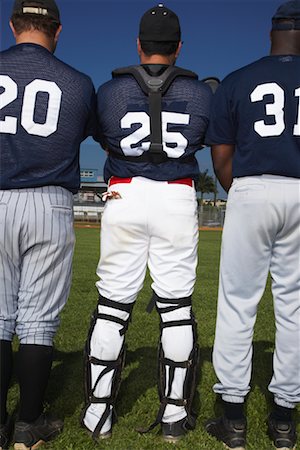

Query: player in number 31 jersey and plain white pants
[206,0,300,449]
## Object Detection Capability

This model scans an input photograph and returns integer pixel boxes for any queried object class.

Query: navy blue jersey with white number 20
[0,44,96,193]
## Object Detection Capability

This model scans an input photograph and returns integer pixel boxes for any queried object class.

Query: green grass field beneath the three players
[10,228,300,450]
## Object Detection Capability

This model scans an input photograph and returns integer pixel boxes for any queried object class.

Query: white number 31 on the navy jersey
[250,83,300,137]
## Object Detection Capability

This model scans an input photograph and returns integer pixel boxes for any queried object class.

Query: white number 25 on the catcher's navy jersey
[120,111,190,158]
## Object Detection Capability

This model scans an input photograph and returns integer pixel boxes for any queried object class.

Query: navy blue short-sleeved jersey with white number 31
[206,55,300,178]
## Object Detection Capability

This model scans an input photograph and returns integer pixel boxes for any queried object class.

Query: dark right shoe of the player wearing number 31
[268,414,297,450]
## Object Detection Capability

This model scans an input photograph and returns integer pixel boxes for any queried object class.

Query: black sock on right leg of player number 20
[17,344,53,422]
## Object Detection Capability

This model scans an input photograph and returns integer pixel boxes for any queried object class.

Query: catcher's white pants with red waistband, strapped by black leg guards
[84,177,198,433]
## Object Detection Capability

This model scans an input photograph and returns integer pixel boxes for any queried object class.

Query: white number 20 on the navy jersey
[0,75,62,137]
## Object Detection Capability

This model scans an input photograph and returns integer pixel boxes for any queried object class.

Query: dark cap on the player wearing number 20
[12,0,60,23]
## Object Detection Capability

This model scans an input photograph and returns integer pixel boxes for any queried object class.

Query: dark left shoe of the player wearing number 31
[205,416,247,450]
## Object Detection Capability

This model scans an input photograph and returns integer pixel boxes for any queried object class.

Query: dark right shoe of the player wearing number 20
[14,414,64,450]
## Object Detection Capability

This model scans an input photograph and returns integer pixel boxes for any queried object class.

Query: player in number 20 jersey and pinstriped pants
[0,0,96,450]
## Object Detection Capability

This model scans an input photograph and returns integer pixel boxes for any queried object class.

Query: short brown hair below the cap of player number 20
[11,13,59,38]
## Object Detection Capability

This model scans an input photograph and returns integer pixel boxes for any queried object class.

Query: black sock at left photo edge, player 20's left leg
[0,340,12,425]
